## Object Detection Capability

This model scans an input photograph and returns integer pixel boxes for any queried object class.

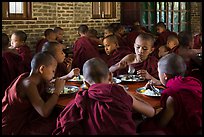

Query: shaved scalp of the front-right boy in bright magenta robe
[158,53,186,76]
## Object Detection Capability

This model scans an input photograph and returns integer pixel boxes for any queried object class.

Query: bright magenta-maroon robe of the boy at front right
[138,76,202,135]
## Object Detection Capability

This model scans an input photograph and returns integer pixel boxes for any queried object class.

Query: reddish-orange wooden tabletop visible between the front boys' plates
[57,81,160,108]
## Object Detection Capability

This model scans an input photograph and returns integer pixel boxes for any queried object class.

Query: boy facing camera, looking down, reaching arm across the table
[109,33,158,80]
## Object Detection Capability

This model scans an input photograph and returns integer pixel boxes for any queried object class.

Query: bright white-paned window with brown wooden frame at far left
[2,2,32,19]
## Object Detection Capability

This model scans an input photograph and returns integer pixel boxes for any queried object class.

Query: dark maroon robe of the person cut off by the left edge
[2,51,24,98]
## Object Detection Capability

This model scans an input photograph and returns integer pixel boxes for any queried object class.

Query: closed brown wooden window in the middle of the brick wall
[92,2,116,19]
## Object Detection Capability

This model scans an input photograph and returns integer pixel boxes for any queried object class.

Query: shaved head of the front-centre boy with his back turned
[83,58,109,83]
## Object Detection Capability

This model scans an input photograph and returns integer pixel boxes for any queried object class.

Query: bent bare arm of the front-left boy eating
[24,80,64,117]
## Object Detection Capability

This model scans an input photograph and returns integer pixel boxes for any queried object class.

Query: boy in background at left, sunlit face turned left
[10,30,33,72]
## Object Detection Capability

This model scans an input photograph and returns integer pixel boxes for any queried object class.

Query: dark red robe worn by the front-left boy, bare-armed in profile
[2,73,57,135]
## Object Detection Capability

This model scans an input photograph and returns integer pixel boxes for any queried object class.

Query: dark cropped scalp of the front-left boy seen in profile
[31,52,57,70]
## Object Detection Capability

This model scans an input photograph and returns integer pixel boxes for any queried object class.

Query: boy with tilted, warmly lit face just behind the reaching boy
[103,35,131,75]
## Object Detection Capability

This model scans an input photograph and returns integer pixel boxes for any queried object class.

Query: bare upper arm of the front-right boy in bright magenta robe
[157,96,175,127]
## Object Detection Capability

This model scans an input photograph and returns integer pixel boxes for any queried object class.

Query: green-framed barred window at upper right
[142,2,190,33]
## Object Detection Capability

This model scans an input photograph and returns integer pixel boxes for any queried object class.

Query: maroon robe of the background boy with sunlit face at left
[16,45,33,72]
